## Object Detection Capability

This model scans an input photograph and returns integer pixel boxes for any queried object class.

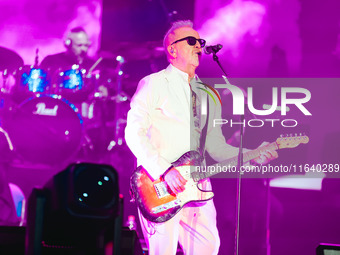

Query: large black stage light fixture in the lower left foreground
[25,163,123,255]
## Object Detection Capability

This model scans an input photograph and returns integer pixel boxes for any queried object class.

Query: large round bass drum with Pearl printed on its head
[5,95,83,165]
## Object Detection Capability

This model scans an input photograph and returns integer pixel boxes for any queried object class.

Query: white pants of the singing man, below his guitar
[139,179,220,255]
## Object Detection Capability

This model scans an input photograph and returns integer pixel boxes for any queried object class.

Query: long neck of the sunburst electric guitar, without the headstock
[192,142,279,180]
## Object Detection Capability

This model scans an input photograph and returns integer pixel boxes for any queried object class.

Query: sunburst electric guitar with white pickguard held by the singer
[130,136,309,223]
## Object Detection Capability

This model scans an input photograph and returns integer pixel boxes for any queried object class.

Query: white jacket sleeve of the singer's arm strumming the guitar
[125,76,171,180]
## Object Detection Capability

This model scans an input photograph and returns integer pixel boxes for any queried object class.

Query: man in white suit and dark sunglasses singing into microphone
[125,21,277,255]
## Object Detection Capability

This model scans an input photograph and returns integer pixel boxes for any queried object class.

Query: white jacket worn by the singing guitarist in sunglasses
[125,65,238,180]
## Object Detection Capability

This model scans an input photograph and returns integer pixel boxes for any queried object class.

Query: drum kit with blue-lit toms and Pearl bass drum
[0,43,155,166]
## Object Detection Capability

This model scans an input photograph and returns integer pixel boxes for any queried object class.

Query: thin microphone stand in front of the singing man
[212,48,245,255]
